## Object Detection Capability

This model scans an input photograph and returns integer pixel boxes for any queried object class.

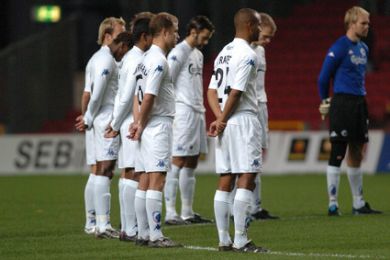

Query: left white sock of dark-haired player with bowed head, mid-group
[164,164,180,220]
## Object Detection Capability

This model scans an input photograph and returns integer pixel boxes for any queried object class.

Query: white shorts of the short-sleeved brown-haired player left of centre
[135,116,173,172]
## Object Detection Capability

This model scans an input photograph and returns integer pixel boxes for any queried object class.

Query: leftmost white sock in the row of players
[84,173,96,228]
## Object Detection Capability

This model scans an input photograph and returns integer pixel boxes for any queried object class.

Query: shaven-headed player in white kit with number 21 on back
[208,8,267,253]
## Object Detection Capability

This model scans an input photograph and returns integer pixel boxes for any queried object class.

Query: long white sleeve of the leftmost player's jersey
[84,52,116,128]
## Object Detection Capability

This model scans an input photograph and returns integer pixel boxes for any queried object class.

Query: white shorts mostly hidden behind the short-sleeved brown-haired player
[118,116,137,169]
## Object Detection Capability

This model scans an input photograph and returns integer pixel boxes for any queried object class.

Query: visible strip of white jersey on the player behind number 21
[253,45,267,103]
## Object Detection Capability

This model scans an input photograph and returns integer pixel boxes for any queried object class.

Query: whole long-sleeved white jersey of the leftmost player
[84,46,118,128]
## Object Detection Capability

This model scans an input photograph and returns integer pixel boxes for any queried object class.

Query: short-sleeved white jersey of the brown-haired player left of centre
[135,44,175,118]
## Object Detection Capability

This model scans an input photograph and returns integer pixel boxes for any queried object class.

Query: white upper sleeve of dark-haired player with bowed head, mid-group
[168,41,192,84]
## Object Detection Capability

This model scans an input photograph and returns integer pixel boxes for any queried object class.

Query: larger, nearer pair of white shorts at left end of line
[93,106,120,162]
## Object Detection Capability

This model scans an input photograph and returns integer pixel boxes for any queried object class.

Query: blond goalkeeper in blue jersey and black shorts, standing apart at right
[318,6,381,216]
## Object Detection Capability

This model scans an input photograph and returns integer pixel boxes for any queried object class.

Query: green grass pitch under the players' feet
[0,175,390,259]
